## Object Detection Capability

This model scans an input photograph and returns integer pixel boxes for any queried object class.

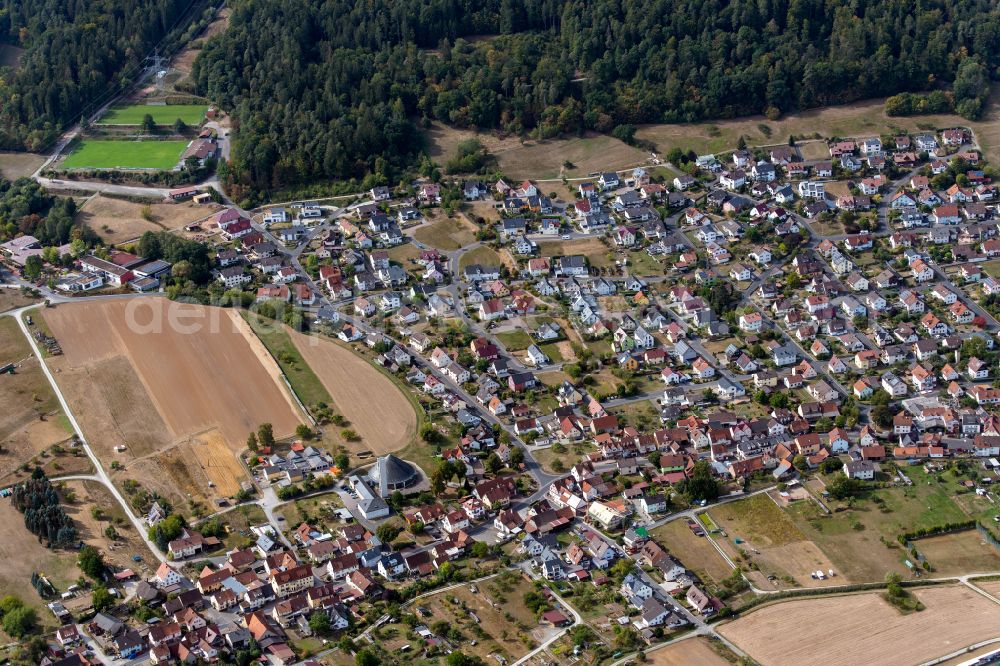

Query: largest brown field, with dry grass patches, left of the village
[40,297,301,498]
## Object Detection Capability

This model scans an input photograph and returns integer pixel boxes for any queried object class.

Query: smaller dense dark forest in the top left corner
[0,0,213,150]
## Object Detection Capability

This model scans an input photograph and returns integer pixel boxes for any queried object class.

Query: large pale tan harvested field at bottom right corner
[718,585,1000,666]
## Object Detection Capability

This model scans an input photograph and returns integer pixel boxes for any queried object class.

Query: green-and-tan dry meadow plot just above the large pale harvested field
[710,494,845,589]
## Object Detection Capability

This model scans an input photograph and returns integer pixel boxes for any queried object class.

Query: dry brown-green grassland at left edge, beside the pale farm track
[0,317,76,485]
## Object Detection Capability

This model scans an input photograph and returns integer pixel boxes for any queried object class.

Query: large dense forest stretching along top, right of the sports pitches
[195,0,1000,197]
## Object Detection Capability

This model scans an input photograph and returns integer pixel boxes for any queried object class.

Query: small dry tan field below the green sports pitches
[77,194,219,244]
